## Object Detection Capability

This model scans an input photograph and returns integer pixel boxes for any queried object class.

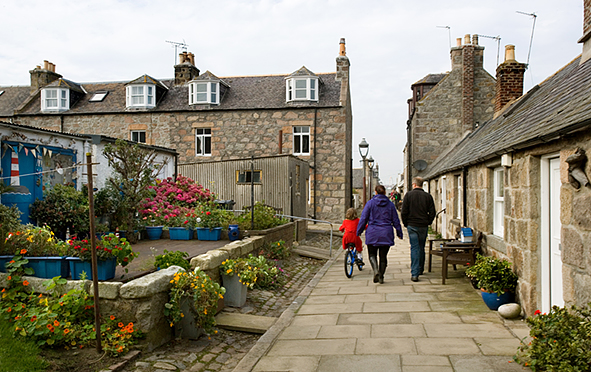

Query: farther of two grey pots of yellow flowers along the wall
[220,258,257,307]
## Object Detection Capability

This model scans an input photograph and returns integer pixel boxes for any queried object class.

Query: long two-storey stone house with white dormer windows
[0,39,353,221]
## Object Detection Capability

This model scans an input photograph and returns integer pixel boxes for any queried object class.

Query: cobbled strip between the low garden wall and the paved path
[117,255,324,372]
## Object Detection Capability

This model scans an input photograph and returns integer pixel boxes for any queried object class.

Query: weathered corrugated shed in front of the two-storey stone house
[178,155,310,217]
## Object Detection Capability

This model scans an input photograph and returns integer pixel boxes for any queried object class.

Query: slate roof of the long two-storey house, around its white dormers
[0,73,341,117]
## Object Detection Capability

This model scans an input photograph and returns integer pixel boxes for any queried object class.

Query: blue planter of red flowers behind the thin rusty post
[67,233,138,280]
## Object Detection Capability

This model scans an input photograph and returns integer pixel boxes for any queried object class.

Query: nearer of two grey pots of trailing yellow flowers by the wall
[164,268,226,339]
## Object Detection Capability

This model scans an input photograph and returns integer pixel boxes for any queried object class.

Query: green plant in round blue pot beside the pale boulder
[466,254,518,310]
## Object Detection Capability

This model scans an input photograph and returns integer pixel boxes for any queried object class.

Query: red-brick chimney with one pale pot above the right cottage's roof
[495,45,527,113]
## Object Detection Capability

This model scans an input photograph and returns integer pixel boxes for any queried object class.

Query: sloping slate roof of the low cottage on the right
[424,57,591,178]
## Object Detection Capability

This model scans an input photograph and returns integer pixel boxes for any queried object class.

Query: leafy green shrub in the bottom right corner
[515,304,591,372]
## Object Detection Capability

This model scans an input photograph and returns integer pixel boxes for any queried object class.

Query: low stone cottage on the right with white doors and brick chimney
[422,0,591,315]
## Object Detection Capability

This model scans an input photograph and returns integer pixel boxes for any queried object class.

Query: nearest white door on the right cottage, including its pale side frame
[540,157,564,312]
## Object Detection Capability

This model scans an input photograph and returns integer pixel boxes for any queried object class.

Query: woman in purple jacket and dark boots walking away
[357,185,402,284]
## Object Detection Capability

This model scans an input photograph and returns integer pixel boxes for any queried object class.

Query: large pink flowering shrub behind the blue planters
[140,175,215,226]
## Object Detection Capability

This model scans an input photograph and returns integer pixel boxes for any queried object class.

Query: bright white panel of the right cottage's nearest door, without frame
[549,158,564,306]
